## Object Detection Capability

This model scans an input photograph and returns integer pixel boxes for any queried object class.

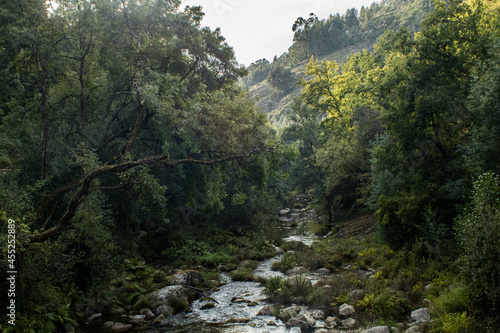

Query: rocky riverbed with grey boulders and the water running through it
[84,197,431,333]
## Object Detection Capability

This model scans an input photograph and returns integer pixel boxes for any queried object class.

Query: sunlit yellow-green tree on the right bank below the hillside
[300,52,381,220]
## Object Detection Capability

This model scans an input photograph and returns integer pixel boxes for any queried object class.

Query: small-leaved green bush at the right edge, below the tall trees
[456,173,500,313]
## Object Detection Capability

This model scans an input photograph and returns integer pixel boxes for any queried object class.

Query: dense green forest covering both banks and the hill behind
[0,0,500,332]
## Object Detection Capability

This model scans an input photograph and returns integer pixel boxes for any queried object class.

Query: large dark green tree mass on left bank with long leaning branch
[0,0,280,326]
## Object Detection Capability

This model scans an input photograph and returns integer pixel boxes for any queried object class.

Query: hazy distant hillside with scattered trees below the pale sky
[240,0,431,128]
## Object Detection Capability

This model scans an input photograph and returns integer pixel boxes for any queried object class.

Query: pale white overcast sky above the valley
[183,0,376,66]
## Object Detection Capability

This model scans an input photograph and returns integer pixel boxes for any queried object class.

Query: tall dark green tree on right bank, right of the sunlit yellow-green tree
[372,1,490,245]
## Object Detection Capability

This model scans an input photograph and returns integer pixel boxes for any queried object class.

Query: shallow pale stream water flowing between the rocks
[152,214,318,333]
